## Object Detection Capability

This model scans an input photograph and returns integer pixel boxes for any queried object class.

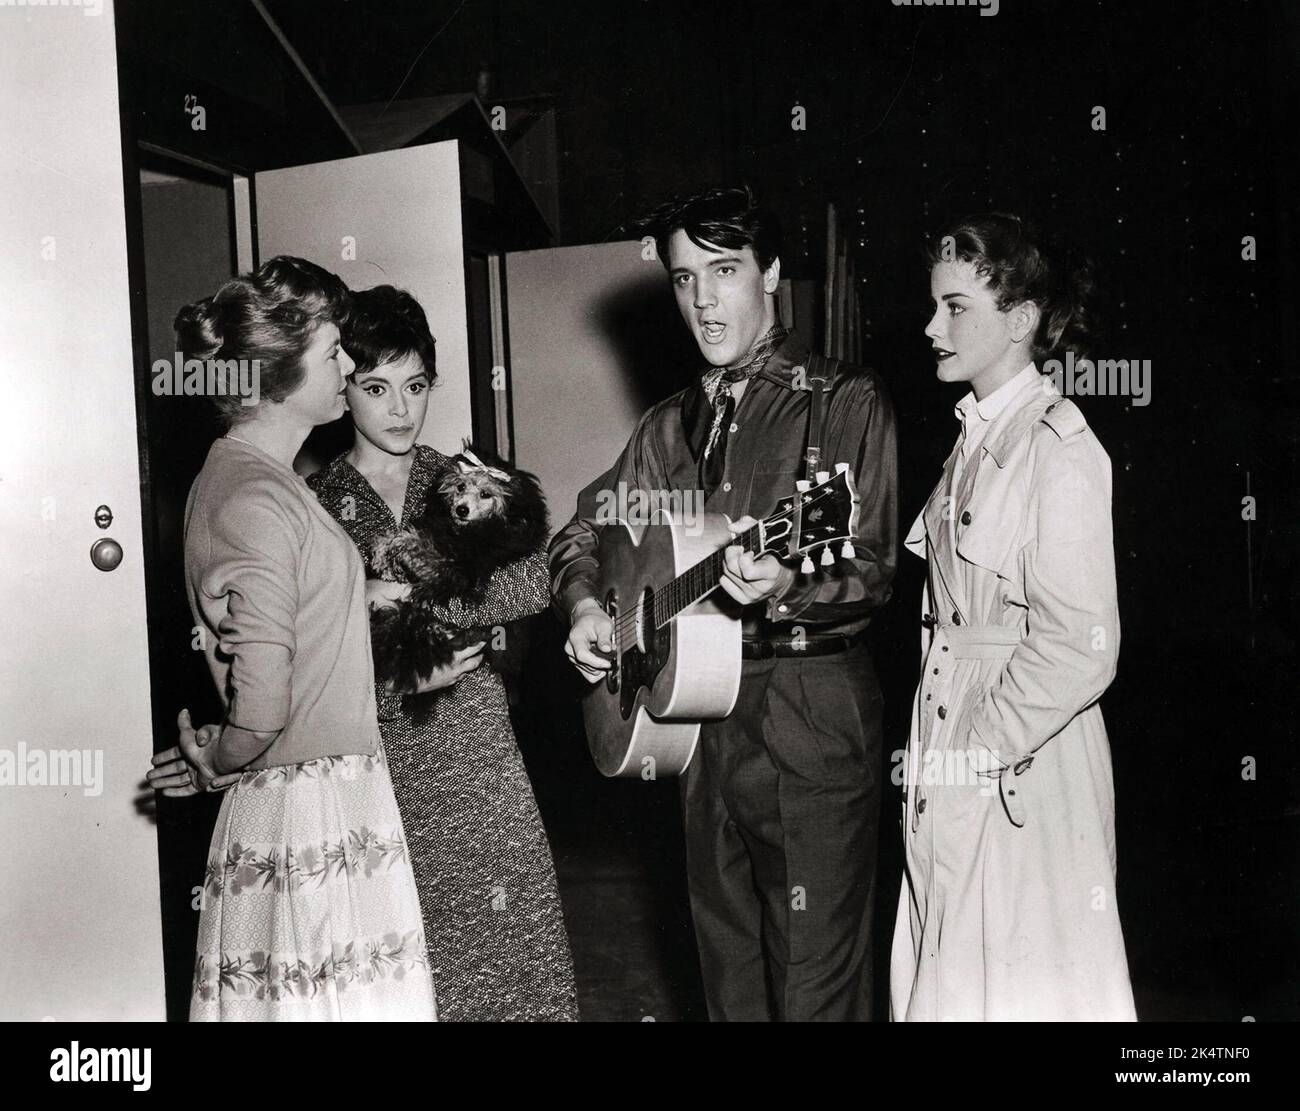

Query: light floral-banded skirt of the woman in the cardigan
[190,747,437,1021]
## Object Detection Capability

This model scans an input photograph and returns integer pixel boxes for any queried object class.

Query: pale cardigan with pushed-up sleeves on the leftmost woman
[185,438,380,769]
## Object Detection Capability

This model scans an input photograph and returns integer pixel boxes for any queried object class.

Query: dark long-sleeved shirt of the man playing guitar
[549,338,898,635]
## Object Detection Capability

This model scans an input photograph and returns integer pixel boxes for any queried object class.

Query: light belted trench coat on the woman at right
[891,378,1135,1021]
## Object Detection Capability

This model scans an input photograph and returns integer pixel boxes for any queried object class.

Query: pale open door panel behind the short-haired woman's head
[255,140,471,455]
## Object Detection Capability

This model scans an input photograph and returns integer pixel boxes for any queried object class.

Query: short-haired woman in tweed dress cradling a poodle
[308,286,577,1021]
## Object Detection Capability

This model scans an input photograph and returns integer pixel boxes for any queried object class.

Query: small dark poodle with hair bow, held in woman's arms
[371,443,550,690]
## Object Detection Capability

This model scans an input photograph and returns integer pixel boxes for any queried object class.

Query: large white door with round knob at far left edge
[0,4,164,1020]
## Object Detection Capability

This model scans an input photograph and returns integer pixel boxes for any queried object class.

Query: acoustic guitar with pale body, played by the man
[582,463,858,778]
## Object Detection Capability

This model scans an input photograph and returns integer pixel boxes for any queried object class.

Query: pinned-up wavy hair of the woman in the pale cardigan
[172,255,352,428]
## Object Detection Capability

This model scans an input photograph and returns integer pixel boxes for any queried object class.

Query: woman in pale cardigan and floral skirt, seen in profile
[151,257,437,1021]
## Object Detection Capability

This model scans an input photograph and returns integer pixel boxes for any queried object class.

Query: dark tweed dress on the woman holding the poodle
[308,446,577,1023]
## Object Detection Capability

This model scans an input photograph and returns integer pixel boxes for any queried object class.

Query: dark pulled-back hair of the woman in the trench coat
[926,212,1097,369]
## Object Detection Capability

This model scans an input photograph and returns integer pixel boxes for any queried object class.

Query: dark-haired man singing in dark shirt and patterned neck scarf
[550,188,897,1021]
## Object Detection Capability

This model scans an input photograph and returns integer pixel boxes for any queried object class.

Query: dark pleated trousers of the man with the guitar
[683,643,881,1021]
